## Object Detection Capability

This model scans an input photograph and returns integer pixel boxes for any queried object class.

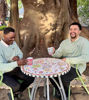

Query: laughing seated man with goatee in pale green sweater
[50,22,89,97]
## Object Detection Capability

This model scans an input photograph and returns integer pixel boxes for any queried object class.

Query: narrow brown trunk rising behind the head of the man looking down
[10,0,20,45]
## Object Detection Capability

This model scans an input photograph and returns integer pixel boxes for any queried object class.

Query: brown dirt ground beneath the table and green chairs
[0,87,89,100]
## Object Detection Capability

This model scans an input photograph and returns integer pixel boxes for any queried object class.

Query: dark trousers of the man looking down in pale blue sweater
[3,67,34,93]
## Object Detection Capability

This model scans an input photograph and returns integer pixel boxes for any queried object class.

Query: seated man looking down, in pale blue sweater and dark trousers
[0,27,34,97]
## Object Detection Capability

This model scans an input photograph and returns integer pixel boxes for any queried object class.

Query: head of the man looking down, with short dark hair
[4,27,16,45]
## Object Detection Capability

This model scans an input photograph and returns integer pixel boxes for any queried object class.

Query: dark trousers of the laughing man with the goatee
[50,67,78,97]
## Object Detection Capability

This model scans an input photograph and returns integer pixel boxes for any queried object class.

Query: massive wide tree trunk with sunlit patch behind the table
[20,0,88,57]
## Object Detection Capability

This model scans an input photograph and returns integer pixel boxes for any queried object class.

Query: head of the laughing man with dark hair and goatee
[69,22,82,40]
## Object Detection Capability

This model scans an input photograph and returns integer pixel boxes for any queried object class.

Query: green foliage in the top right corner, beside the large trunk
[77,0,89,25]
